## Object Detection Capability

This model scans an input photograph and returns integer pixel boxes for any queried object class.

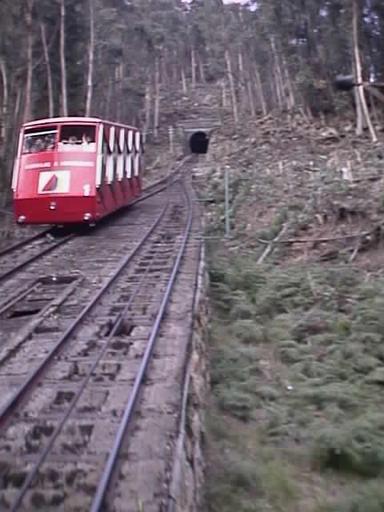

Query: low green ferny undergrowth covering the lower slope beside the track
[207,251,384,512]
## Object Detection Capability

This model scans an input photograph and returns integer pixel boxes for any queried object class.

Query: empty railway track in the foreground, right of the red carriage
[0,167,201,512]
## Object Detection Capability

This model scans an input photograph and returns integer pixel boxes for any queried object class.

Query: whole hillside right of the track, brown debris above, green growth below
[198,109,384,512]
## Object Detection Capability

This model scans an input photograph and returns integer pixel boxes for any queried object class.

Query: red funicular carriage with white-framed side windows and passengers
[12,117,143,224]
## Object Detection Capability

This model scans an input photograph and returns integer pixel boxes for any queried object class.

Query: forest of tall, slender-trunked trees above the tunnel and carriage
[0,0,384,202]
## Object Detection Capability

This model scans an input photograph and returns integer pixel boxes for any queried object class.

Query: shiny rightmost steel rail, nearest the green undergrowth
[90,180,193,512]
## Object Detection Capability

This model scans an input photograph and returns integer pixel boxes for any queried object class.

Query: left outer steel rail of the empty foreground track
[0,195,169,428]
